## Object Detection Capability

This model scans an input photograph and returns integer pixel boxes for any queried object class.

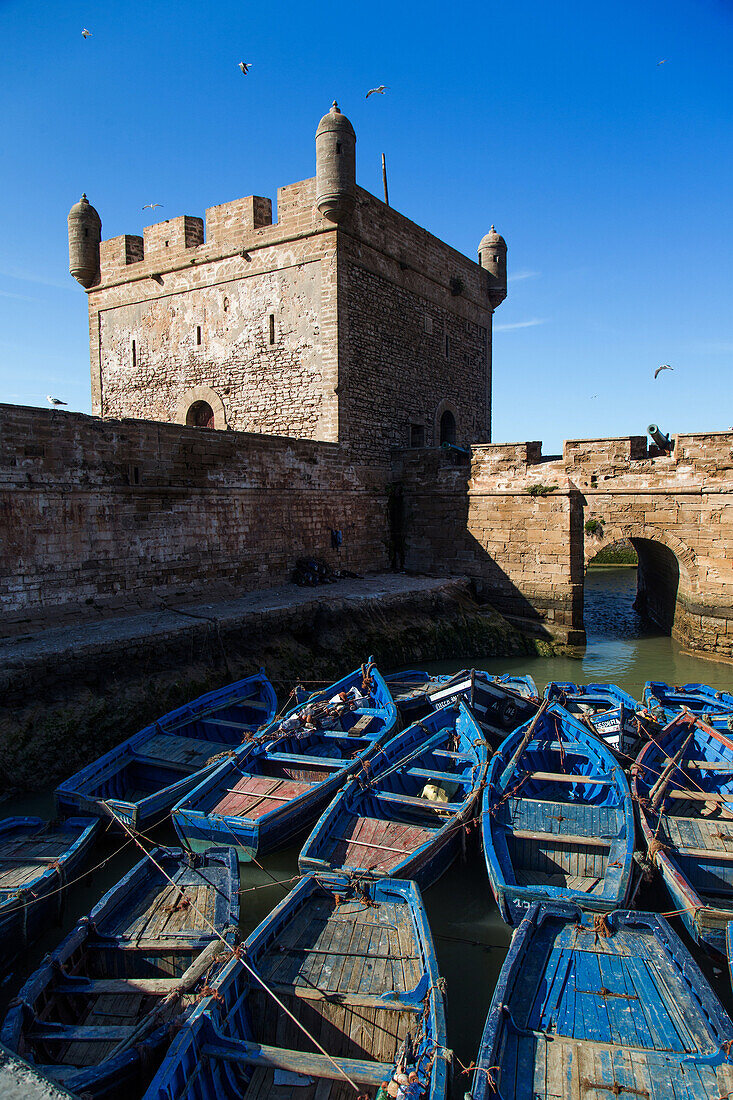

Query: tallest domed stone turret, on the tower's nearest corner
[316,100,357,222]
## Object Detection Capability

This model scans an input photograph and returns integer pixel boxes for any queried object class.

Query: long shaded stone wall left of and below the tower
[0,406,389,633]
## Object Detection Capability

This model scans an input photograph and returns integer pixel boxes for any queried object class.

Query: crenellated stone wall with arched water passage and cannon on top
[394,432,733,657]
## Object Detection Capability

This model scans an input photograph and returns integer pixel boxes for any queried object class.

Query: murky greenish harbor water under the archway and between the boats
[0,567,733,1098]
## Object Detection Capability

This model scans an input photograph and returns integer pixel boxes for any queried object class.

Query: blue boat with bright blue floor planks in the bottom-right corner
[468,903,733,1100]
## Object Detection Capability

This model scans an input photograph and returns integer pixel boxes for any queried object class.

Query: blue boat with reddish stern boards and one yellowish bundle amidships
[298,702,489,889]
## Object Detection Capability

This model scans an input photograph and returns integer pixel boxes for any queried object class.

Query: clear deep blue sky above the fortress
[0,0,733,453]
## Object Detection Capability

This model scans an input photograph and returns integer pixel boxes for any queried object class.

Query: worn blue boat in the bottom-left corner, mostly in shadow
[0,848,239,1098]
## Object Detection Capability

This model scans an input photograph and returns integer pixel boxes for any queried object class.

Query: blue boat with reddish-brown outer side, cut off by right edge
[633,712,733,955]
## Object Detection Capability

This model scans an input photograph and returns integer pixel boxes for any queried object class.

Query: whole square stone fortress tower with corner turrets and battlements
[68,102,506,464]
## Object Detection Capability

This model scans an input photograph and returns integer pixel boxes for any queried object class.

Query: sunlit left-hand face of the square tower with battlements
[89,179,338,441]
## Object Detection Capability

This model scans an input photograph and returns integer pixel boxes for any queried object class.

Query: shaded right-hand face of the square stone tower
[339,188,492,462]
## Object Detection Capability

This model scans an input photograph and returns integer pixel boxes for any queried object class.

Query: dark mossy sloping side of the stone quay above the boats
[0,582,553,792]
